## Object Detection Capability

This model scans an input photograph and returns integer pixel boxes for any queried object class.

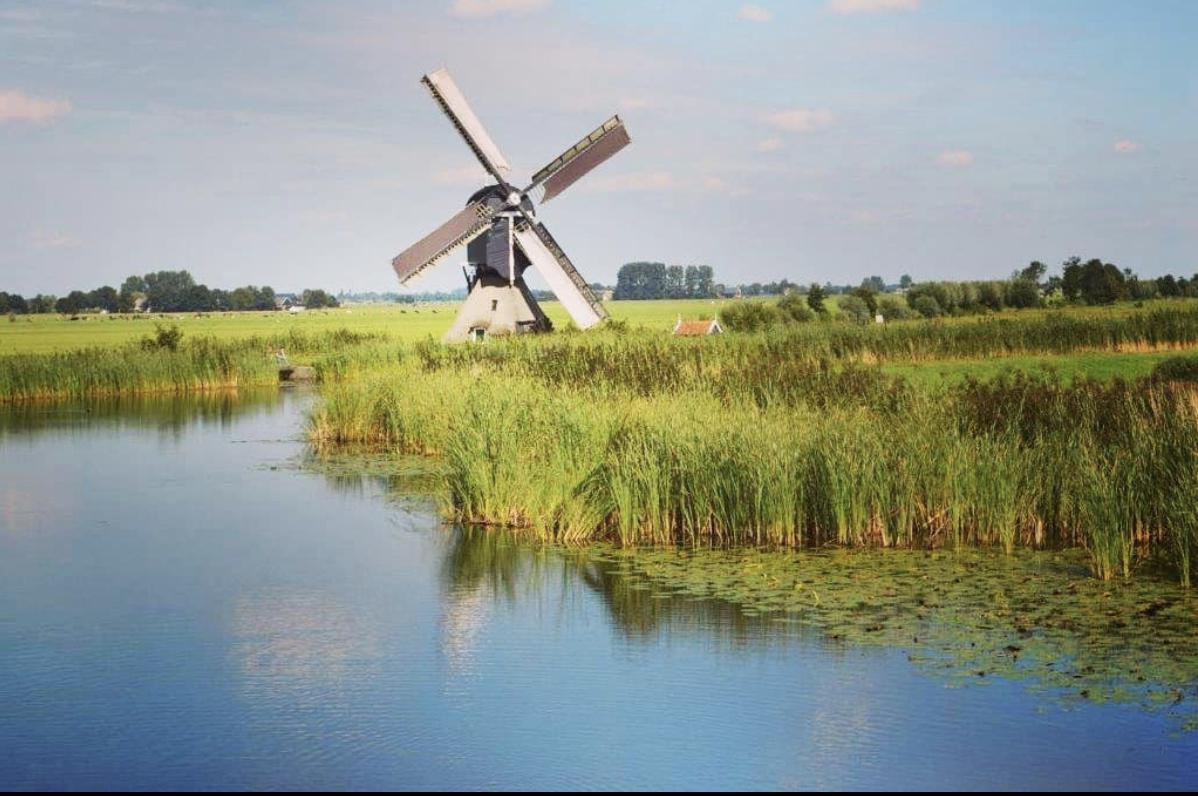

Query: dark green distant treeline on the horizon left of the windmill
[0,271,338,315]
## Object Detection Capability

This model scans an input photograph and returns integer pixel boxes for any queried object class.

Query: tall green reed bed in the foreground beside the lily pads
[310,328,1198,584]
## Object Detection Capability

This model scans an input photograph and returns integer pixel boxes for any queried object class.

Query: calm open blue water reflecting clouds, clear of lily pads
[0,393,1198,789]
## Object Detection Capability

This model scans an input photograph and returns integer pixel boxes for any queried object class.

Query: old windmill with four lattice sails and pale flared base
[392,70,631,340]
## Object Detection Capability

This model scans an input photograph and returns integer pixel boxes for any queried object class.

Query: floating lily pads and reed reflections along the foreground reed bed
[442,527,1198,730]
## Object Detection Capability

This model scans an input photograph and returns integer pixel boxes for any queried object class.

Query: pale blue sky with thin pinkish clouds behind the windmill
[0,0,1198,295]
